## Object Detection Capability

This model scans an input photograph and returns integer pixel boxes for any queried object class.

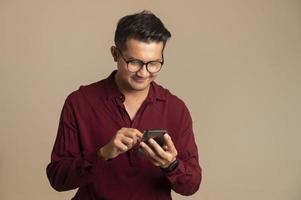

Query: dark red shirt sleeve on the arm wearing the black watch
[166,103,202,195]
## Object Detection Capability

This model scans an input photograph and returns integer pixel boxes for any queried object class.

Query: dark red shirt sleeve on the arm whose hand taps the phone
[46,98,105,191]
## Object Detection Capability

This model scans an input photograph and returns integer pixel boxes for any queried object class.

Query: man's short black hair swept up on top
[114,10,171,50]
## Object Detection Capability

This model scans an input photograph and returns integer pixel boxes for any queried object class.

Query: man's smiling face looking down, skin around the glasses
[113,39,163,92]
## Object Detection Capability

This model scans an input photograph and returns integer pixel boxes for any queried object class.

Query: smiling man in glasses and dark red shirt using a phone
[47,11,201,200]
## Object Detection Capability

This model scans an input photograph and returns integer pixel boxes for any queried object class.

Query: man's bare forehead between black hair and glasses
[125,39,163,60]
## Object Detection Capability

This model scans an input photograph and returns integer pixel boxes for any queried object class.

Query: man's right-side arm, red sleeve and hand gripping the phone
[141,104,202,195]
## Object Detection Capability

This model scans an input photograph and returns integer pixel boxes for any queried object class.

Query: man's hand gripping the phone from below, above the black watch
[140,133,178,168]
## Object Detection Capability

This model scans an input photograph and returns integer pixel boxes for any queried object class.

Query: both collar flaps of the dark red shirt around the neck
[105,70,166,103]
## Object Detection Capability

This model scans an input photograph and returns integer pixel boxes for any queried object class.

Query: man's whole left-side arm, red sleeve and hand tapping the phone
[47,97,142,191]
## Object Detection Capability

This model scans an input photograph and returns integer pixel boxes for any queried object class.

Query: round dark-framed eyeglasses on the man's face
[117,48,164,73]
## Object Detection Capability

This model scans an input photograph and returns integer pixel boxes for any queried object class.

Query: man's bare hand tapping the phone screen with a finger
[97,128,142,160]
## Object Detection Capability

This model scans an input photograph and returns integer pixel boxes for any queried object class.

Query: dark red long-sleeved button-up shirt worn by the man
[47,71,201,200]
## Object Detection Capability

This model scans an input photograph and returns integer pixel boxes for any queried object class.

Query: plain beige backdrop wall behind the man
[0,0,301,200]
